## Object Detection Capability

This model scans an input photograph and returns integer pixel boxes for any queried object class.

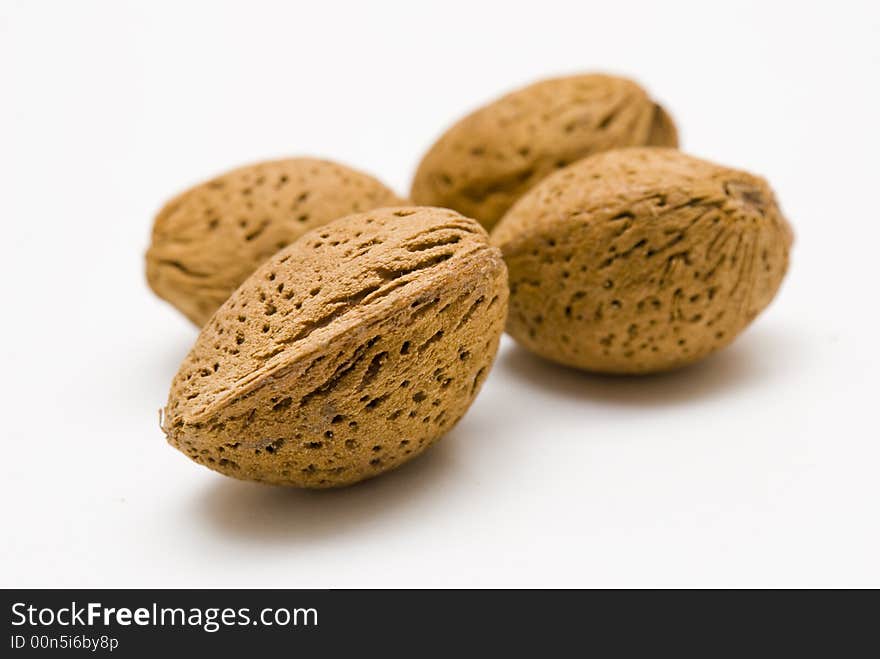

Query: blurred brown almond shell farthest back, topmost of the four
[411,75,678,229]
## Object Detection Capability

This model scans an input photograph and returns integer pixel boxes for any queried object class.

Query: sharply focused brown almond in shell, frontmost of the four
[164,207,507,487]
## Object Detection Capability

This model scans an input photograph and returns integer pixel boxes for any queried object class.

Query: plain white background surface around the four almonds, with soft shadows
[0,0,880,587]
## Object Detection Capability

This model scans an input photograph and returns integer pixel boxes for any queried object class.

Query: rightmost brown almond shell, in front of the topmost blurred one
[492,148,792,373]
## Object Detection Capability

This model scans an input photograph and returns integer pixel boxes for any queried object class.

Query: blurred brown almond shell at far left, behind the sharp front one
[147,158,402,326]
